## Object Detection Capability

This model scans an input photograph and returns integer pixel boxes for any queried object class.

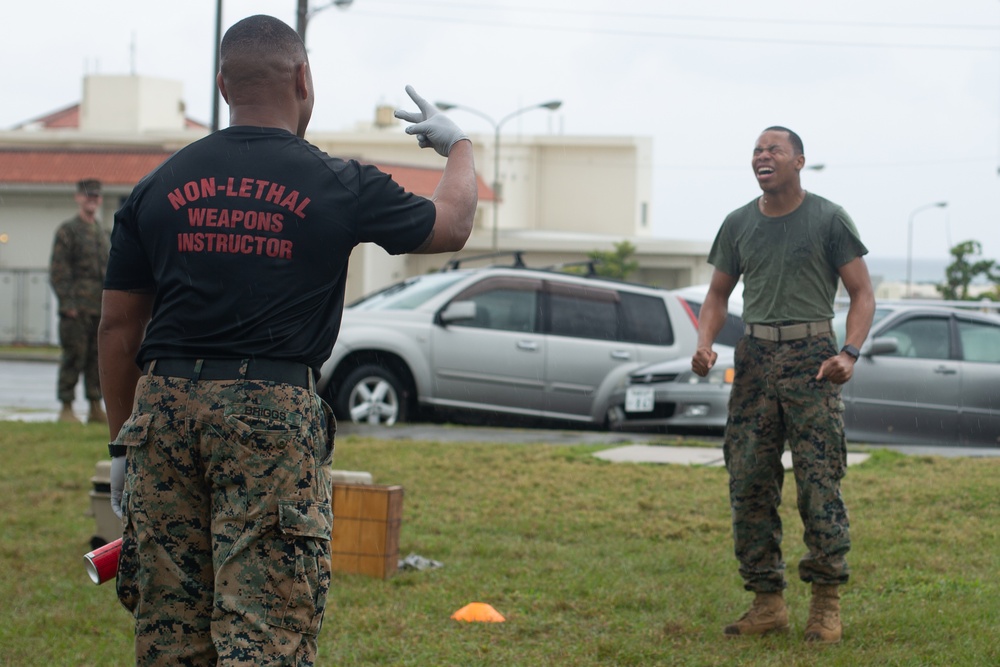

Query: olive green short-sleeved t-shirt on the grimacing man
[708,192,868,324]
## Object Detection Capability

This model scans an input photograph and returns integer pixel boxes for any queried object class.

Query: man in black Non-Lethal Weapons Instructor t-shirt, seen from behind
[99,16,477,665]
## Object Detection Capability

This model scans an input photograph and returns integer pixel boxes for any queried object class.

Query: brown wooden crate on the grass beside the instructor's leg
[331,484,403,579]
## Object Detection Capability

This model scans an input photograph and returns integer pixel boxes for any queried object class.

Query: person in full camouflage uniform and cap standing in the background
[49,179,111,422]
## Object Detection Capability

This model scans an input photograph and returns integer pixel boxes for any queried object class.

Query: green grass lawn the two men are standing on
[0,422,1000,667]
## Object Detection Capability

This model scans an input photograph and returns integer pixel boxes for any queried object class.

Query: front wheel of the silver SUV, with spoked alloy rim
[335,364,407,426]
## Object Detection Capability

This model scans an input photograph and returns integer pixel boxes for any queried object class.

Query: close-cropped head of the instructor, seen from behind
[219,14,308,104]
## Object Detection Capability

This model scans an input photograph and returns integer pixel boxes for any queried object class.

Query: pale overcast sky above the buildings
[0,0,1000,272]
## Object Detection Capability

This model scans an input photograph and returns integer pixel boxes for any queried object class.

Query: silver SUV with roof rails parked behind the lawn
[317,255,697,427]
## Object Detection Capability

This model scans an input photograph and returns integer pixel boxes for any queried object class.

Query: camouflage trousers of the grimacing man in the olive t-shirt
[723,336,851,592]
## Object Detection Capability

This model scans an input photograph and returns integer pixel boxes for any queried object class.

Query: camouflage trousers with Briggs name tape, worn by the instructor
[116,374,336,667]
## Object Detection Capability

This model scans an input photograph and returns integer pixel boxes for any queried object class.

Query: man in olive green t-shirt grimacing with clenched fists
[691,127,875,643]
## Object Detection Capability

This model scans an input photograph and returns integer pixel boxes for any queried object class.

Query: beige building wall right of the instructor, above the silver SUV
[306,123,672,302]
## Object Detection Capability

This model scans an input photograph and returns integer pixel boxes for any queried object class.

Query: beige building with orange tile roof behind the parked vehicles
[0,75,710,343]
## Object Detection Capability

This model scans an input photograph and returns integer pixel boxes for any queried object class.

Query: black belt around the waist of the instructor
[142,359,312,388]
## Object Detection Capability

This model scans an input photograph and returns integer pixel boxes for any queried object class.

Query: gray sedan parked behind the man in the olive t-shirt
[612,304,1000,447]
